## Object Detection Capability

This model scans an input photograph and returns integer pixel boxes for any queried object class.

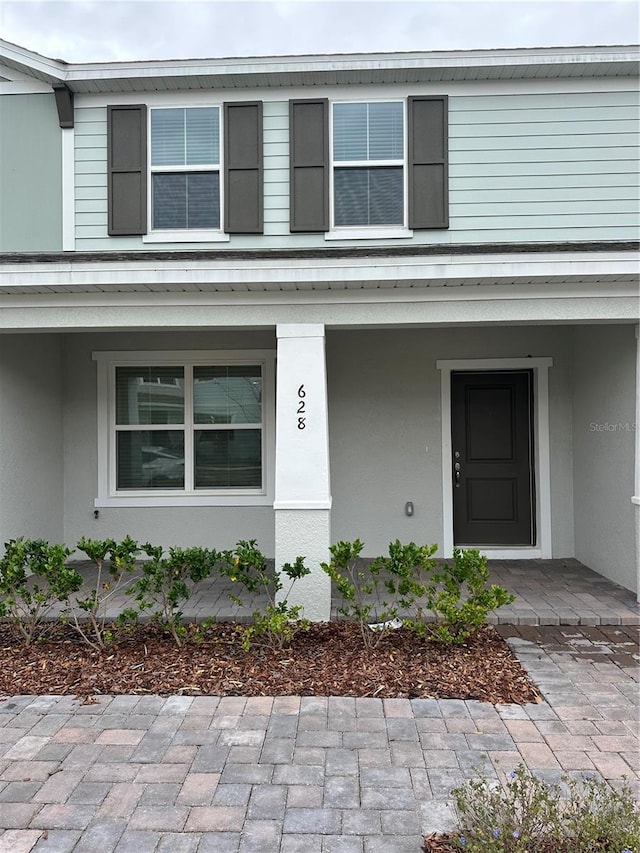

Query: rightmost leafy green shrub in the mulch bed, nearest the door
[427,548,515,643]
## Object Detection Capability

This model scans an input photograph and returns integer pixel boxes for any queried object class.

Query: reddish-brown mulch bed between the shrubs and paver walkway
[0,622,539,704]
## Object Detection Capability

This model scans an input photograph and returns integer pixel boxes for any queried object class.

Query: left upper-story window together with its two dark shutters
[107,102,264,243]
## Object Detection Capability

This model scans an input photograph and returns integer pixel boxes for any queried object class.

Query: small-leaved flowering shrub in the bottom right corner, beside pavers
[452,765,640,853]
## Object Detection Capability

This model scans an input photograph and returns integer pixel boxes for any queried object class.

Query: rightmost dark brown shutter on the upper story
[409,95,449,228]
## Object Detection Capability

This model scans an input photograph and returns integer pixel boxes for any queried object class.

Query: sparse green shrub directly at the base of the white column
[219,539,311,651]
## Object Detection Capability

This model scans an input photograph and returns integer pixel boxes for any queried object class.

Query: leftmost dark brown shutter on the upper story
[107,104,147,236]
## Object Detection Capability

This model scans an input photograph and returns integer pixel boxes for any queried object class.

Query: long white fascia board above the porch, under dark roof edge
[0,252,639,291]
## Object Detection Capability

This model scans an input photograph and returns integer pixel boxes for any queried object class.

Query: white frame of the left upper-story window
[142,103,229,243]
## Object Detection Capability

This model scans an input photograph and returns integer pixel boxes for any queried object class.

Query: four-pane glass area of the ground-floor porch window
[115,364,262,491]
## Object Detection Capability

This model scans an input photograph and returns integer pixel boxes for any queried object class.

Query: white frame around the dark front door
[436,357,553,560]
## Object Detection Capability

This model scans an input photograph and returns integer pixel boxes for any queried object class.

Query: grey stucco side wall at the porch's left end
[0,335,64,545]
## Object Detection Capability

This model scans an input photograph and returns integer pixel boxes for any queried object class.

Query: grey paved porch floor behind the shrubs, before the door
[51,559,640,626]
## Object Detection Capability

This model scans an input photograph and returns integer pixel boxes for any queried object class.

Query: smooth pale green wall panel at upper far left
[0,94,62,252]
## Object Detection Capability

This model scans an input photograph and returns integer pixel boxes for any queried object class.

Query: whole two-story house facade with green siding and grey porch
[0,42,640,619]
